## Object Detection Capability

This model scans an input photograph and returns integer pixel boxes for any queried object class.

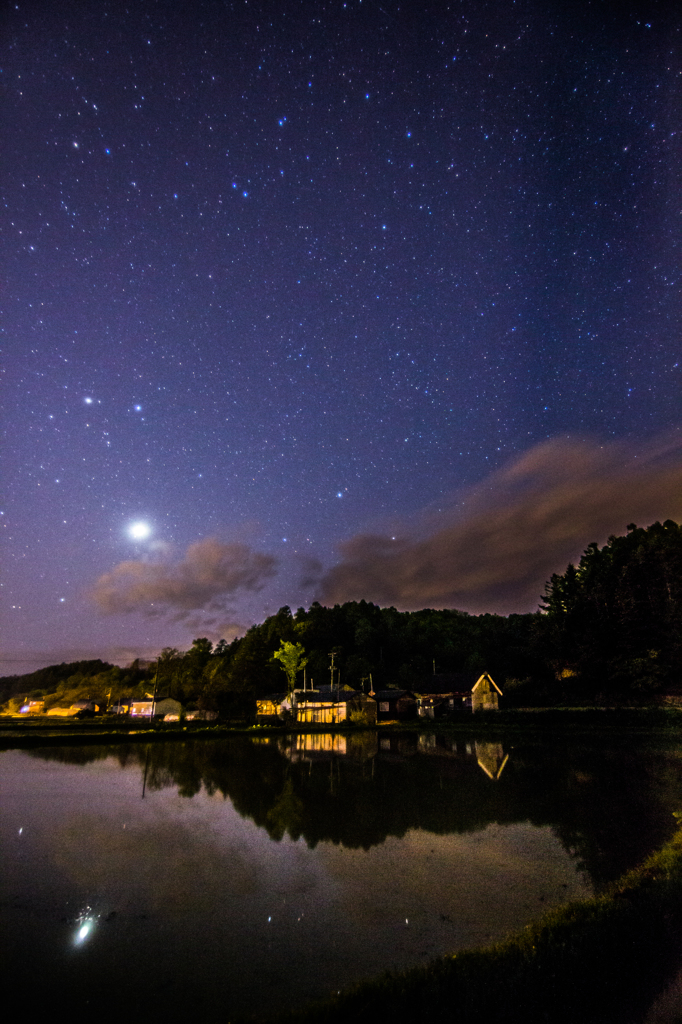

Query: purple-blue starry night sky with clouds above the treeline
[0,0,682,673]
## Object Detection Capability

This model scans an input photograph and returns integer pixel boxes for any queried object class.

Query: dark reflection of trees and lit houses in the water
[26,731,682,887]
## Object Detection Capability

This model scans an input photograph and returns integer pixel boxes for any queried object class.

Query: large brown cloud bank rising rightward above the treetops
[319,436,682,614]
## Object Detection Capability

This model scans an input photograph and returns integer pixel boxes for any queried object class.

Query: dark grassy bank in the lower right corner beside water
[266,828,682,1024]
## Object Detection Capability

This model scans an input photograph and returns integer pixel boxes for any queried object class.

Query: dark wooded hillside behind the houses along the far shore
[0,519,682,719]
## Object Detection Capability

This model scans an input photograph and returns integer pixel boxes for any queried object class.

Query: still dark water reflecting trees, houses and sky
[0,733,682,1021]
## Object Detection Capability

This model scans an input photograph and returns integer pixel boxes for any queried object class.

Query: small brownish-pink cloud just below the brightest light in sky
[91,538,278,618]
